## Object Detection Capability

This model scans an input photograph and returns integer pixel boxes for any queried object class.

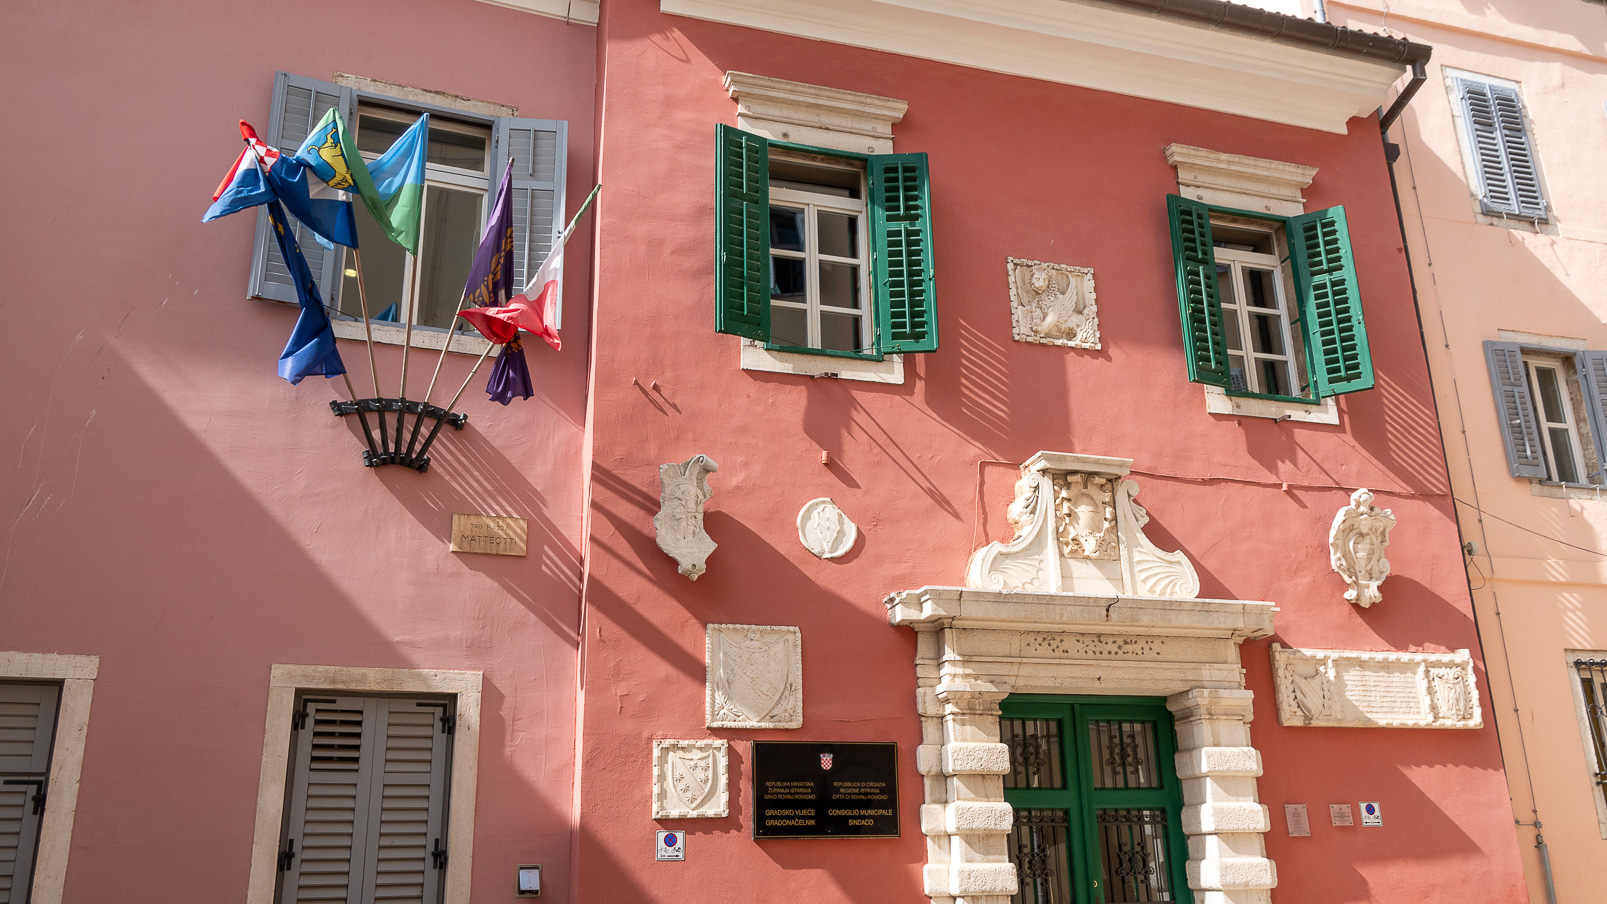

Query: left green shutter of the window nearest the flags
[714,124,770,342]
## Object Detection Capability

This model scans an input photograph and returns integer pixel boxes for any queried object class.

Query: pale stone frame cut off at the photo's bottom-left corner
[0,652,100,904]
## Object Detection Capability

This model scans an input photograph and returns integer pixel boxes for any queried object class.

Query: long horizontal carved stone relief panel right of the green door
[1273,644,1483,729]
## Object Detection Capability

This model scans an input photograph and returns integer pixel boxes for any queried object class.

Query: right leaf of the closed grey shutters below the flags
[363,698,452,904]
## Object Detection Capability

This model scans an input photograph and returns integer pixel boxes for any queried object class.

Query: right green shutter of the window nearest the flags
[868,154,937,355]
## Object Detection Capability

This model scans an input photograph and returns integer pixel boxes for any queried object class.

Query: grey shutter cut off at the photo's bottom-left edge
[0,684,61,904]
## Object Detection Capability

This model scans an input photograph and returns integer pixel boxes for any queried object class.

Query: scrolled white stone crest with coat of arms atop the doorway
[966,451,1200,599]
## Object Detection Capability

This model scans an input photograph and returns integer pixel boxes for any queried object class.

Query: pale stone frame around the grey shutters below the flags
[244,663,482,904]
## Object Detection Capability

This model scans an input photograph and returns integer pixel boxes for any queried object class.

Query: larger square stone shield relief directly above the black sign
[705,625,804,729]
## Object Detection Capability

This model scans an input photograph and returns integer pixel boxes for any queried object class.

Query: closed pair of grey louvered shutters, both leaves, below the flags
[278,694,452,904]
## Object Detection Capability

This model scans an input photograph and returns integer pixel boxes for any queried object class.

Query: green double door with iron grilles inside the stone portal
[1000,694,1192,904]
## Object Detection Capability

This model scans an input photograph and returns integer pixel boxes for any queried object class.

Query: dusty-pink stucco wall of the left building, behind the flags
[0,0,596,904]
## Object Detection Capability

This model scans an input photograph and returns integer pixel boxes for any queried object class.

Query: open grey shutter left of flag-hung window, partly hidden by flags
[249,72,355,308]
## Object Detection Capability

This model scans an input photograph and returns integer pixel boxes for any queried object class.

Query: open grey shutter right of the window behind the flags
[485,117,569,328]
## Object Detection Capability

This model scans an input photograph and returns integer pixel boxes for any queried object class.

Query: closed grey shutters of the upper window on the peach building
[1456,79,1546,220]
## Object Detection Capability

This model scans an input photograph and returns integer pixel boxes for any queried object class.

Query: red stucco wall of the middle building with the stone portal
[579,0,1522,902]
